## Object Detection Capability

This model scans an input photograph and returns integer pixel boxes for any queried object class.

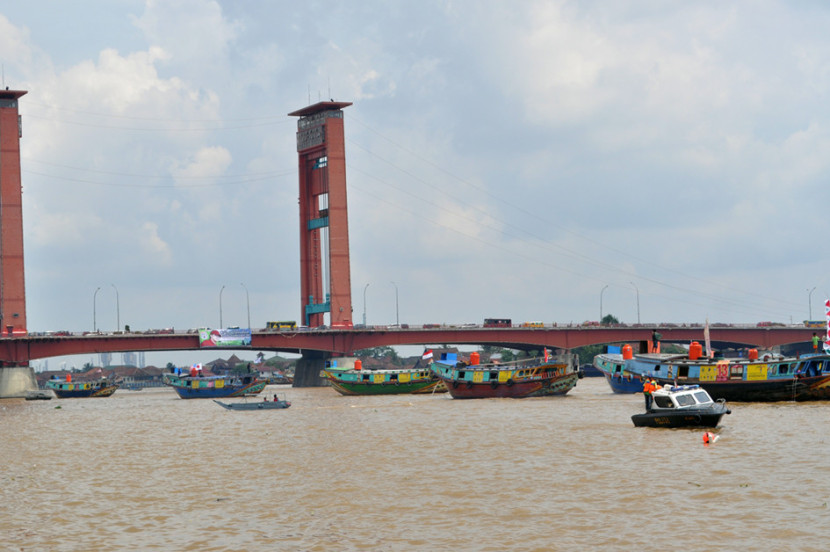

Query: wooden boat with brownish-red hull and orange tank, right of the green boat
[431,353,580,399]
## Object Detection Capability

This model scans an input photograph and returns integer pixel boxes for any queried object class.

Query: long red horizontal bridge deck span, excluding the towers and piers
[0,326,815,365]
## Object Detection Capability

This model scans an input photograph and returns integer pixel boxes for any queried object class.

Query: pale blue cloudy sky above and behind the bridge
[0,0,830,370]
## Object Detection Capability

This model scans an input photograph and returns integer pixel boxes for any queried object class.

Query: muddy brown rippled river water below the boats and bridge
[0,378,830,551]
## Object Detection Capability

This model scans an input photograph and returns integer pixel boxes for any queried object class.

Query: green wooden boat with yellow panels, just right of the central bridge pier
[320,359,447,395]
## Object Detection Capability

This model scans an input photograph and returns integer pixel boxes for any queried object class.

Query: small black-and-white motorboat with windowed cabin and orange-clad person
[631,385,731,427]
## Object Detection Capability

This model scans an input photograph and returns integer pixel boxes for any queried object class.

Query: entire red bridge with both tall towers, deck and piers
[0,89,815,398]
